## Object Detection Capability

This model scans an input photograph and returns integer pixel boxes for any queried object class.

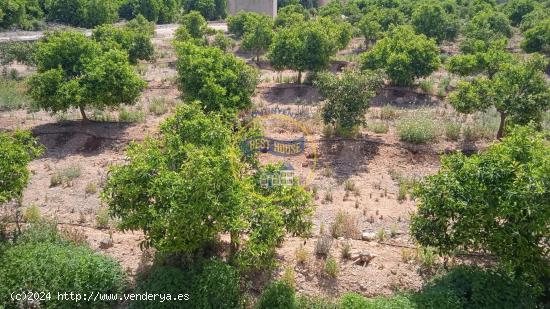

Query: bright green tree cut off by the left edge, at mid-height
[0,131,44,204]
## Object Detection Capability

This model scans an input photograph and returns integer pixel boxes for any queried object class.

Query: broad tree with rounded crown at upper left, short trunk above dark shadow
[29,31,146,120]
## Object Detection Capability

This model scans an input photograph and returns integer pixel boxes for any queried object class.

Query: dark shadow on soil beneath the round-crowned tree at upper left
[31,121,131,159]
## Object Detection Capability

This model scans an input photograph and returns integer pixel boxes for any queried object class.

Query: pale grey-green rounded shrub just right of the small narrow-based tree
[397,114,438,145]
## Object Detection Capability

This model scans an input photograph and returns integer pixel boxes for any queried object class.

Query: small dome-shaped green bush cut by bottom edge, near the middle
[257,281,297,309]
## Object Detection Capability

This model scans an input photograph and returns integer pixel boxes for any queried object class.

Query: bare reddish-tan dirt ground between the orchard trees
[0,31,498,297]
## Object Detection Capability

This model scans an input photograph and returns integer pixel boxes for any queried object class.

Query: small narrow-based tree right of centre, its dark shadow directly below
[315,71,383,135]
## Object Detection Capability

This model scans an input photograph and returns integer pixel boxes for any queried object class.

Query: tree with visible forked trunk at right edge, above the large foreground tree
[449,57,550,139]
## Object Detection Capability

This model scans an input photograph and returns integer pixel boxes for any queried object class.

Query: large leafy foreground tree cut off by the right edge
[411,127,550,277]
